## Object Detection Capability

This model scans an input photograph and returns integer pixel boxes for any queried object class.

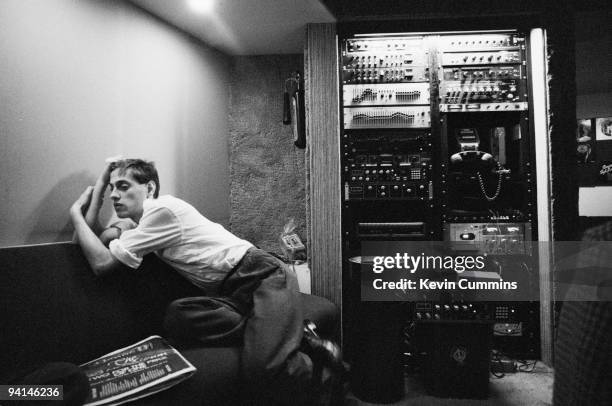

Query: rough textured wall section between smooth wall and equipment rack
[229,55,306,252]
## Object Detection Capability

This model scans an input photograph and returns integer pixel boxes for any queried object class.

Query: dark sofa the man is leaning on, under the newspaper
[0,243,338,405]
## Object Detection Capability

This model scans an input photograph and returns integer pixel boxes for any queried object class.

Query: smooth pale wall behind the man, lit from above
[0,0,229,246]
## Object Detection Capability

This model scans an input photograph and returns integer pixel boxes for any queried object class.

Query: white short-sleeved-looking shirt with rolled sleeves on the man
[109,195,253,290]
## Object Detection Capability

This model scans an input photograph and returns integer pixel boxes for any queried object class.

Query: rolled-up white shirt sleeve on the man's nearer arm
[108,207,182,269]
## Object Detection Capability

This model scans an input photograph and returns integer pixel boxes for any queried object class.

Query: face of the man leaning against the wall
[110,169,149,223]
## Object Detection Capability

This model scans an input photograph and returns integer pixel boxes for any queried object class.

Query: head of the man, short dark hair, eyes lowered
[110,159,159,222]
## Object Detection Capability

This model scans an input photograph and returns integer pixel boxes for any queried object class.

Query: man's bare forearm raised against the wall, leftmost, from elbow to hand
[70,186,121,276]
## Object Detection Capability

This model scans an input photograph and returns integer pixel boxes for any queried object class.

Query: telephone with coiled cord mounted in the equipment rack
[450,128,508,202]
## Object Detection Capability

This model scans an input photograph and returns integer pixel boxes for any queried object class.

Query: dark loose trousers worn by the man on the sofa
[165,248,313,405]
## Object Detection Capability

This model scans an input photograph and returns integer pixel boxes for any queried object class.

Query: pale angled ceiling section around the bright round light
[130,0,336,55]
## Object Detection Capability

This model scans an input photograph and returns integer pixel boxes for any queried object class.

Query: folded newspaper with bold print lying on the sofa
[81,336,196,406]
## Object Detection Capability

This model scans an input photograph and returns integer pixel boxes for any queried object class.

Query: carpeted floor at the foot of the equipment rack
[345,363,553,406]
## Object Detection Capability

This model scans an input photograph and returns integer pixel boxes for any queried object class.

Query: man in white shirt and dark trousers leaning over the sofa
[2,159,343,405]
